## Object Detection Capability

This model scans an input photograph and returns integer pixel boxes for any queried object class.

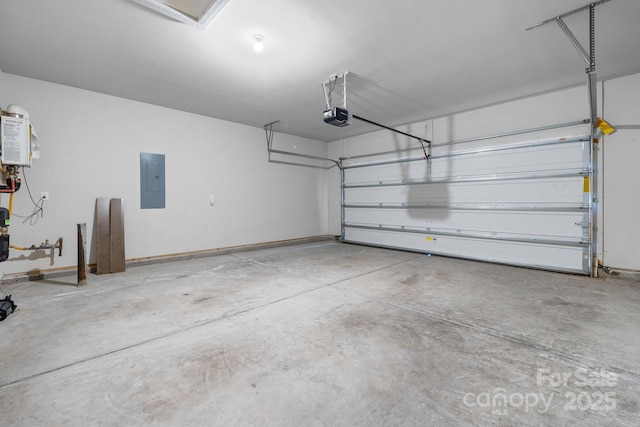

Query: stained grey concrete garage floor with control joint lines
[0,242,640,426]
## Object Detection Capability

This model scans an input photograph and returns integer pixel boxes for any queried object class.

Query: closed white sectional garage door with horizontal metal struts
[342,123,591,274]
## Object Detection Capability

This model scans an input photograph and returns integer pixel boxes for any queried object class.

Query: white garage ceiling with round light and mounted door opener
[0,0,640,141]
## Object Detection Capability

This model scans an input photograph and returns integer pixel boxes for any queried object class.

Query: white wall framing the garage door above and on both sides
[328,74,640,270]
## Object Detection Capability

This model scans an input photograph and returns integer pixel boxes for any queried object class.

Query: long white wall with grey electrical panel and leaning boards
[0,74,327,277]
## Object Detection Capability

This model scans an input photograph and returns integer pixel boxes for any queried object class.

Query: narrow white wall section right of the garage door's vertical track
[601,74,640,270]
